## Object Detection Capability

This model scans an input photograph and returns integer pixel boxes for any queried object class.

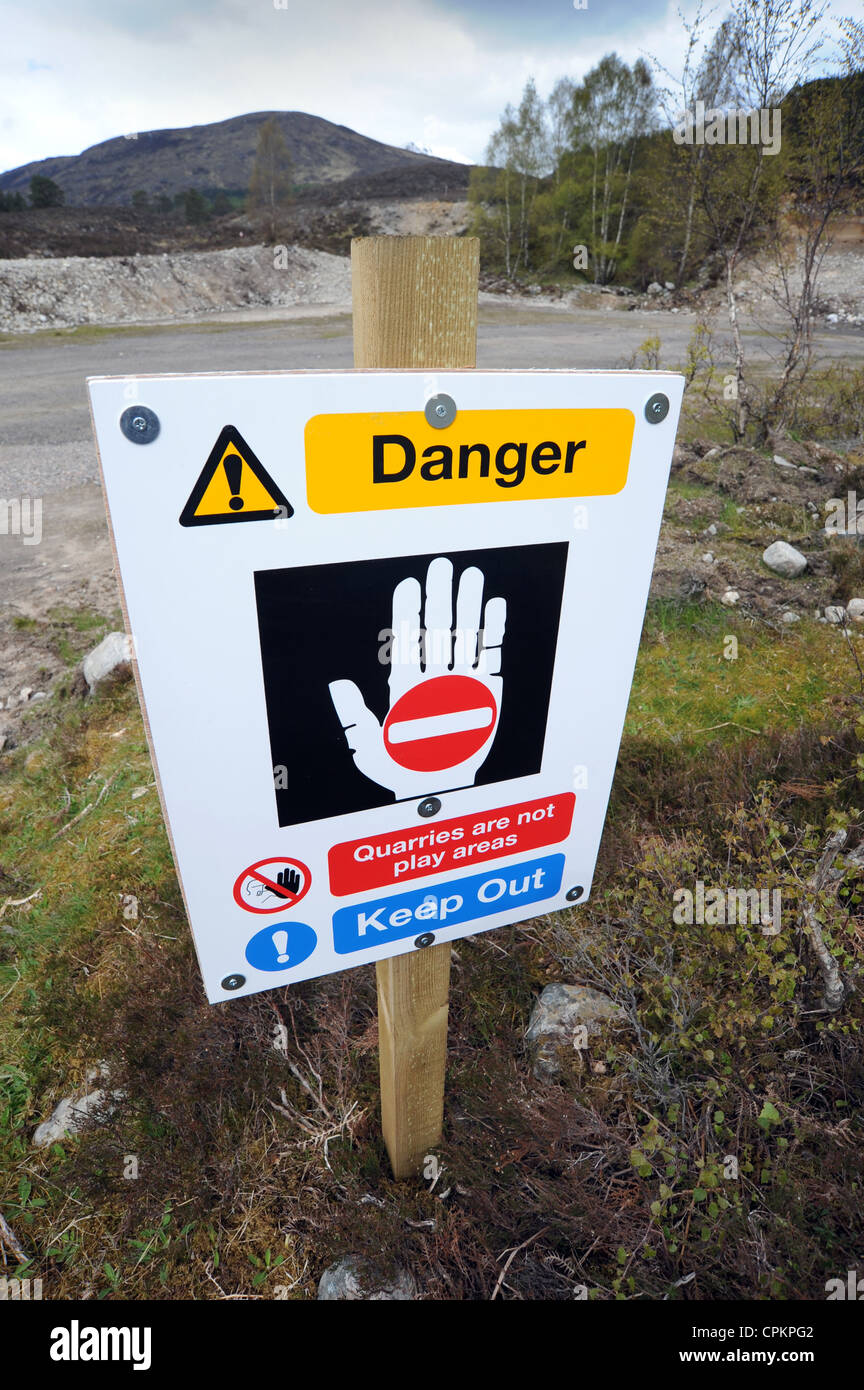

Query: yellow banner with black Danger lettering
[306,409,635,513]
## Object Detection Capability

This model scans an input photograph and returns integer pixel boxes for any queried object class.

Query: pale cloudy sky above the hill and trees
[0,0,864,171]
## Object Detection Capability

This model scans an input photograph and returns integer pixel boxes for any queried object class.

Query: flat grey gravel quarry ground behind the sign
[0,295,864,633]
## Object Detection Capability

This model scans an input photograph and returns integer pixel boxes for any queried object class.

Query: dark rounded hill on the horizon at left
[0,111,470,206]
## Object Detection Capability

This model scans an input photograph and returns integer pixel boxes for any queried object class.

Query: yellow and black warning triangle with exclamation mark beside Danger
[181,425,294,525]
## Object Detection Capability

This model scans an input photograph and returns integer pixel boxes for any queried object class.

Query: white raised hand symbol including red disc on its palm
[329,556,507,801]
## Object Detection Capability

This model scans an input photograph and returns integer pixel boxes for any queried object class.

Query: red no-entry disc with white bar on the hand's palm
[383,676,497,773]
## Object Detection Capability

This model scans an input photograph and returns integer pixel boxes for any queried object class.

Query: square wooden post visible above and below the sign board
[351,236,479,1177]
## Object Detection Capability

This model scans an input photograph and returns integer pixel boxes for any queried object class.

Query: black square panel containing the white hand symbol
[254,542,568,826]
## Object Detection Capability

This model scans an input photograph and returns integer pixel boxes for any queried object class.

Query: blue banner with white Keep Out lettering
[333,855,564,955]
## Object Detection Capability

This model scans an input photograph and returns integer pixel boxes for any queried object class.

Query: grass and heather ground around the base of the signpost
[0,589,863,1300]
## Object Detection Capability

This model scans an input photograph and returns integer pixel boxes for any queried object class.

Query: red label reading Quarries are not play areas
[328,791,576,897]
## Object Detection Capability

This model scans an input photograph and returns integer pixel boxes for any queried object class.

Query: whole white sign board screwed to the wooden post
[89,371,683,1002]
